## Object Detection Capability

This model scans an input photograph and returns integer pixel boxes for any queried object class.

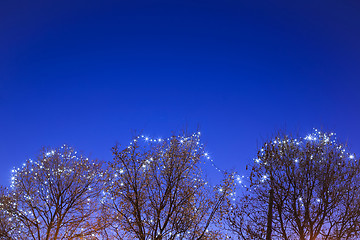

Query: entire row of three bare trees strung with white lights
[0,131,360,240]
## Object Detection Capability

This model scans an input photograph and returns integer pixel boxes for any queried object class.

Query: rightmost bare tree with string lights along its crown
[228,130,360,240]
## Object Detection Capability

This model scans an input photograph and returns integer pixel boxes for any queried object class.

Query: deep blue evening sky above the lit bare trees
[0,0,360,185]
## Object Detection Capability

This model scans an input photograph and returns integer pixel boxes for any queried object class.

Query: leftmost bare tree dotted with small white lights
[0,145,102,240]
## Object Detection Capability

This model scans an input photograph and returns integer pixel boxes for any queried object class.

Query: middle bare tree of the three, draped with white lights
[103,134,232,240]
